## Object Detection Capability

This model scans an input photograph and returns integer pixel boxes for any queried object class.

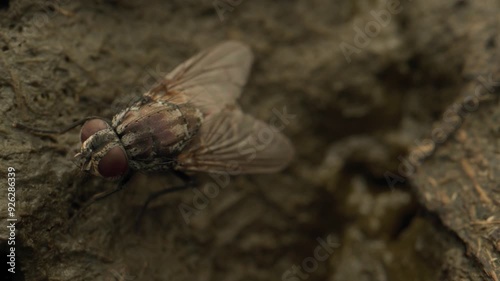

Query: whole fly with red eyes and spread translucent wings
[17,41,294,207]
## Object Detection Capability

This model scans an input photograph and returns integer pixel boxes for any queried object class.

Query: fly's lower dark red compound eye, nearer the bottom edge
[98,146,128,178]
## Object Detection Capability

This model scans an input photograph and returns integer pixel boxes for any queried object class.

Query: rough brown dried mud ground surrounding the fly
[0,0,500,281]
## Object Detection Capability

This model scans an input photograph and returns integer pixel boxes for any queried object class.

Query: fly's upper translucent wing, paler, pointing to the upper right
[145,41,253,116]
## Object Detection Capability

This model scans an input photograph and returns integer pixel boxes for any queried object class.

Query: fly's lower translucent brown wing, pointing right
[177,107,294,174]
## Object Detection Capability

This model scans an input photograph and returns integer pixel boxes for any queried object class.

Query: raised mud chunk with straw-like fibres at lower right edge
[415,94,500,280]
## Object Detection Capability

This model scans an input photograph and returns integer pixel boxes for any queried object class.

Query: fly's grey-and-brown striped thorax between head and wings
[113,101,202,170]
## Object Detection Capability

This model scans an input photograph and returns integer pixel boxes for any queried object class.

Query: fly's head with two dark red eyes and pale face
[75,119,129,178]
